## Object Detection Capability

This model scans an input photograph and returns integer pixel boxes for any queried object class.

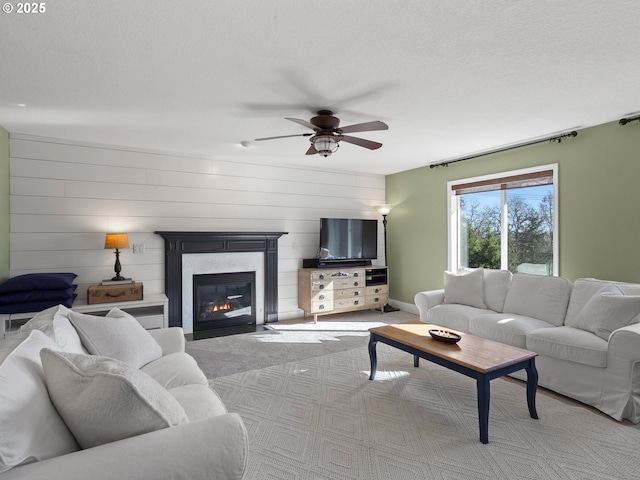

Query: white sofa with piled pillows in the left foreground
[0,306,248,480]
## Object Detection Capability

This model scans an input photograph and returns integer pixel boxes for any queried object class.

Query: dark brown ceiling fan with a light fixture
[255,110,389,157]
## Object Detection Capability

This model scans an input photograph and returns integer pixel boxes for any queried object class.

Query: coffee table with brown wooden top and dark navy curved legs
[369,320,538,443]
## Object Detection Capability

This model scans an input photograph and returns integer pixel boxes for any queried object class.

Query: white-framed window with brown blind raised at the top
[448,164,558,275]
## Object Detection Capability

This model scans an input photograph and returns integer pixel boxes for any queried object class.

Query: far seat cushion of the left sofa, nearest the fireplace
[141,352,208,389]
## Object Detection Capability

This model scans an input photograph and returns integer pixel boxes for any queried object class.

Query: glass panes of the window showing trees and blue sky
[459,185,554,275]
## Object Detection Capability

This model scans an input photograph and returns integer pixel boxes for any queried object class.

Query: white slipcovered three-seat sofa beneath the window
[415,269,640,423]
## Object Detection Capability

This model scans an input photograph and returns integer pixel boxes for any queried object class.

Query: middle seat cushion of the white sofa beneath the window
[468,313,553,348]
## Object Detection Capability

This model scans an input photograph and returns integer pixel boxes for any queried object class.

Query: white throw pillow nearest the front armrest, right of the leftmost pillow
[40,348,189,448]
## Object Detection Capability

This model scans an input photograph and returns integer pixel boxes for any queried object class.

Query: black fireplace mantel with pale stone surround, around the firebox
[155,231,287,334]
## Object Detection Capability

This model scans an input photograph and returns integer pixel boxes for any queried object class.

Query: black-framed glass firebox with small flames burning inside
[193,272,256,331]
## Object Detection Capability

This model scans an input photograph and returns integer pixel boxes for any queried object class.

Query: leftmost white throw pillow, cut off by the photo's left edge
[0,330,78,472]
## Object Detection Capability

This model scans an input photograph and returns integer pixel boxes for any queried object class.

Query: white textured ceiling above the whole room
[0,0,640,174]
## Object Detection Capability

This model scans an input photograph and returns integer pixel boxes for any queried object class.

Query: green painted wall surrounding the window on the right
[386,122,640,303]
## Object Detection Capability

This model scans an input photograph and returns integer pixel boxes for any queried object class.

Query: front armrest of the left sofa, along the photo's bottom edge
[0,413,248,480]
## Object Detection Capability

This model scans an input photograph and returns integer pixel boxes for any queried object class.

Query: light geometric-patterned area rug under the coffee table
[211,344,640,480]
